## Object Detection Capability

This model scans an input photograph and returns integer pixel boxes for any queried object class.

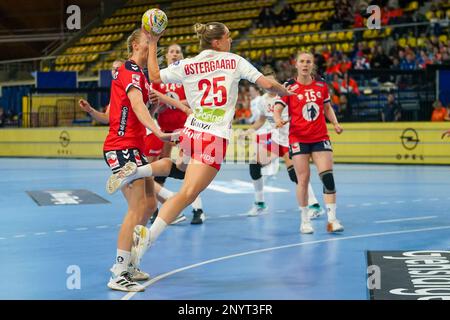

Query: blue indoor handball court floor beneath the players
[0,158,450,300]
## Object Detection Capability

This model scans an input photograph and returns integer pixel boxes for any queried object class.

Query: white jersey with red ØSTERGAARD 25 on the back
[160,50,262,139]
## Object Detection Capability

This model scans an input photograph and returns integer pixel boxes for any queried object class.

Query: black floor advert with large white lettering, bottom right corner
[367,250,450,300]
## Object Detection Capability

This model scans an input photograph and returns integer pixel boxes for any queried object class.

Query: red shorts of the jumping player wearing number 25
[180,128,228,170]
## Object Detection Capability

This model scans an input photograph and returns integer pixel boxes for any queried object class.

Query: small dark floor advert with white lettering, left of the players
[27,189,110,206]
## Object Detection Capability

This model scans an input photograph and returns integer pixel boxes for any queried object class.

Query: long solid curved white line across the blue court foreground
[121,226,450,300]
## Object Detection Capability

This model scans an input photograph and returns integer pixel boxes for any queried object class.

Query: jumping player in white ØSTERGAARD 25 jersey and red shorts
[107,22,291,268]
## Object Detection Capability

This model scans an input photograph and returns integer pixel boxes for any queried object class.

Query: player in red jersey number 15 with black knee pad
[274,52,344,233]
